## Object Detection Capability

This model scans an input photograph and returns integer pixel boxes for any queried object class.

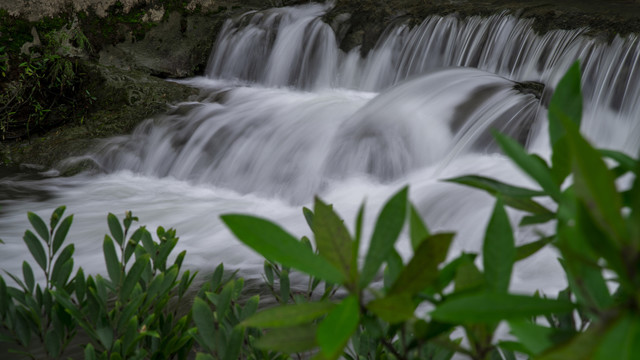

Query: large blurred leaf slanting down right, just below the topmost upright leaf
[563,115,627,245]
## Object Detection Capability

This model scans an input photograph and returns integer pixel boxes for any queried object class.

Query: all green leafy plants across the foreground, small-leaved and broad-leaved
[0,64,640,360]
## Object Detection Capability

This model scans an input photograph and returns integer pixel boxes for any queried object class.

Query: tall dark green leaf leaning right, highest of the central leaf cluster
[359,187,409,289]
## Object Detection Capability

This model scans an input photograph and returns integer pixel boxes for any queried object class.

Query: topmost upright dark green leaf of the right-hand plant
[549,61,582,146]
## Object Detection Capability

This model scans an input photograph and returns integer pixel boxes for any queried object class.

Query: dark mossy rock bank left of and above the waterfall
[0,0,640,173]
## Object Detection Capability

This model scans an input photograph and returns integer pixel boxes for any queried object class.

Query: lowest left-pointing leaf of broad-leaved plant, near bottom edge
[255,325,318,354]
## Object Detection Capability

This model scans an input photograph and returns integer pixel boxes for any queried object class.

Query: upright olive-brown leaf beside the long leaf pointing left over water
[312,198,355,281]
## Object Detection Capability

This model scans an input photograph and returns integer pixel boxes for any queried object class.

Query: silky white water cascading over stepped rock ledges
[0,4,640,291]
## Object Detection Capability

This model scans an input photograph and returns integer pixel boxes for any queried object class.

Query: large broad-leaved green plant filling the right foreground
[222,63,640,359]
